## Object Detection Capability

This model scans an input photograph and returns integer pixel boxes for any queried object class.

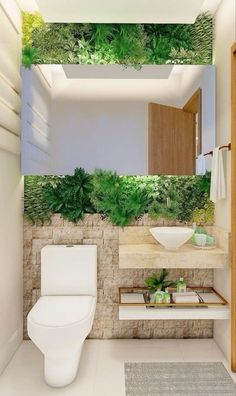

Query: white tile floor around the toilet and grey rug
[0,340,236,396]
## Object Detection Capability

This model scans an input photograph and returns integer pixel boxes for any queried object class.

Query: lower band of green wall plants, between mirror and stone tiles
[24,168,214,227]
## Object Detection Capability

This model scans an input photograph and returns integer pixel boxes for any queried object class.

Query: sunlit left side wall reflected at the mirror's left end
[21,66,52,175]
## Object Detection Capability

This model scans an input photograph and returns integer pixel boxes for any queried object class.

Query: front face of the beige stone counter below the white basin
[119,243,229,269]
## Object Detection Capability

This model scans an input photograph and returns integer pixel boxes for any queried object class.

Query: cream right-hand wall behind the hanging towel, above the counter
[215,0,236,230]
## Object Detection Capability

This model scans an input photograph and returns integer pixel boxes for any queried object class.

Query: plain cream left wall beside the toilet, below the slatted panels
[0,149,23,373]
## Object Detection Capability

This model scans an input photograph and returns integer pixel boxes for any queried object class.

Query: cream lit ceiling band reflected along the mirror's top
[35,65,211,105]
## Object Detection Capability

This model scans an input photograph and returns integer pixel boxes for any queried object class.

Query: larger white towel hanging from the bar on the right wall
[210,147,226,202]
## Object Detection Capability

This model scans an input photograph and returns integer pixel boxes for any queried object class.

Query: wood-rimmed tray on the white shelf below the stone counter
[119,286,228,308]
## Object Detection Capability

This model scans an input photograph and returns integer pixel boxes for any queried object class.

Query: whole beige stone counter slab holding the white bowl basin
[119,227,229,268]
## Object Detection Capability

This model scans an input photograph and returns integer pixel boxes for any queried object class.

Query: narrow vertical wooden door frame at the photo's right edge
[231,43,236,372]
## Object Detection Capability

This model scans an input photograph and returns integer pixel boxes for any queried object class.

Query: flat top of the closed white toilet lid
[28,296,96,327]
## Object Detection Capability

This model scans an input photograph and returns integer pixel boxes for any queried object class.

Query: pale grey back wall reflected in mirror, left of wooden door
[52,99,148,175]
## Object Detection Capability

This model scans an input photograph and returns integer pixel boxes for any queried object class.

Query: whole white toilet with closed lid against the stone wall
[27,245,97,387]
